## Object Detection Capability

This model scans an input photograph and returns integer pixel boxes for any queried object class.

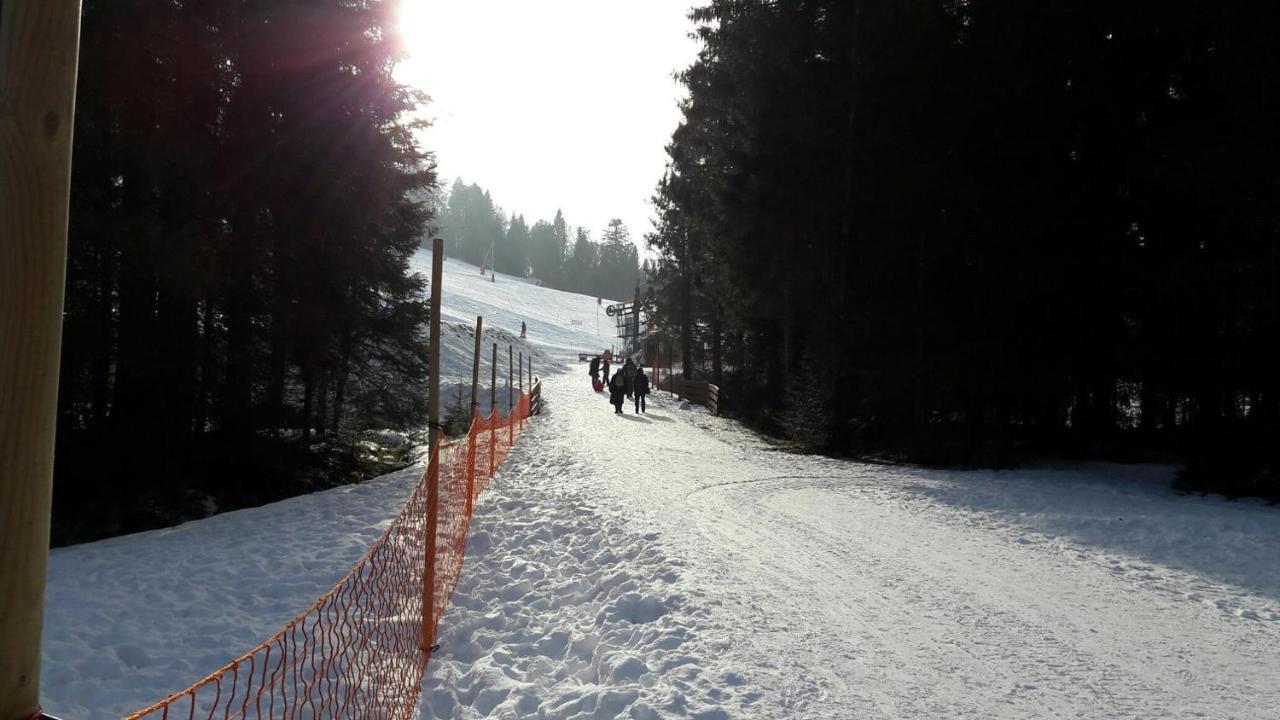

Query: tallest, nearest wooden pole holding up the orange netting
[422,237,444,652]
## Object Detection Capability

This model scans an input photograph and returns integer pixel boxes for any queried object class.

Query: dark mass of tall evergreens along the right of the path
[650,0,1280,498]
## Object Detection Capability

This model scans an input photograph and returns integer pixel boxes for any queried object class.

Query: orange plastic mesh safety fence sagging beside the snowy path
[127,393,529,720]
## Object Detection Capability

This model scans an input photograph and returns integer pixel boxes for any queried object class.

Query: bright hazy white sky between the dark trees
[398,0,698,247]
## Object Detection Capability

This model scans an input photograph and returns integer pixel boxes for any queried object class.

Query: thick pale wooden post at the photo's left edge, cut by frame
[0,0,81,720]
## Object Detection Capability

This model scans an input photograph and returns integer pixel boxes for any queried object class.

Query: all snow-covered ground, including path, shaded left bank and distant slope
[42,249,1280,720]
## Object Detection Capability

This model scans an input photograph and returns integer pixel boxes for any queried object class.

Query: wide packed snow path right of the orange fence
[424,366,1280,719]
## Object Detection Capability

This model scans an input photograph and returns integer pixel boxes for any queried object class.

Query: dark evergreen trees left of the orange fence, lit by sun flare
[54,0,435,543]
